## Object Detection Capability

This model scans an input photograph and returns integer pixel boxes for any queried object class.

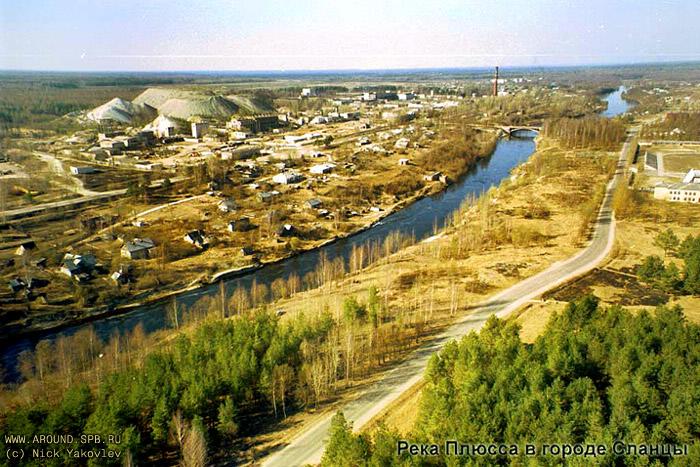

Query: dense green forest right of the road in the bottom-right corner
[322,296,700,466]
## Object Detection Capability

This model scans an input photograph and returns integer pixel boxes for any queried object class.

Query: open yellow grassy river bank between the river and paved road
[250,134,616,460]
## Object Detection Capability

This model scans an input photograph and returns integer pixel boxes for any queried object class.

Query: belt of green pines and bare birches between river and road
[0,274,454,465]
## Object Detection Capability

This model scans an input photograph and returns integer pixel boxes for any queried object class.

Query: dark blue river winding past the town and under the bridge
[1,86,629,380]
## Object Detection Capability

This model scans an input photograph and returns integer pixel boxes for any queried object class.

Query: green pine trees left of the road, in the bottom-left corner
[0,312,333,465]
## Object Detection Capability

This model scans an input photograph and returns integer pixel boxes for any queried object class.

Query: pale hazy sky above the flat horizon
[0,0,700,71]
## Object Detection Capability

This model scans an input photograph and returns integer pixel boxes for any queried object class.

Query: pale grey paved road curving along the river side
[263,129,636,467]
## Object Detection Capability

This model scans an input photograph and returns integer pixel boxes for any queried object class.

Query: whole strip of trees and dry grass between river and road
[2,122,624,462]
